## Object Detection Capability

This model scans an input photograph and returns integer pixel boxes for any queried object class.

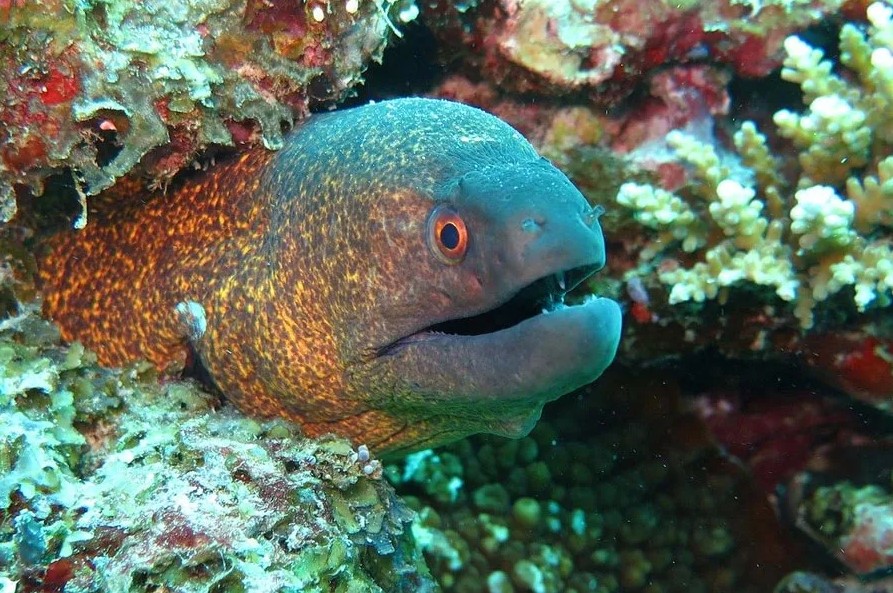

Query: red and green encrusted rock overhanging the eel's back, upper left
[0,0,417,223]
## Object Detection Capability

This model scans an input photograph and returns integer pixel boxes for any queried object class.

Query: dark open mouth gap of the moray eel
[424,266,599,336]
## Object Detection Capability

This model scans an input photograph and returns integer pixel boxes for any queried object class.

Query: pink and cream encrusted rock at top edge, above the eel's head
[426,0,841,104]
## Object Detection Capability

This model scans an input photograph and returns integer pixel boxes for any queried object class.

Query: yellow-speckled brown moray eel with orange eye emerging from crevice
[40,99,621,454]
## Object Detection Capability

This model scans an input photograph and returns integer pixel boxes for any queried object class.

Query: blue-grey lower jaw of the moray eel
[379,274,621,410]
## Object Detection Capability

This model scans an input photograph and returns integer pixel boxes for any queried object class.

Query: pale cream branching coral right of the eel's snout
[617,2,893,328]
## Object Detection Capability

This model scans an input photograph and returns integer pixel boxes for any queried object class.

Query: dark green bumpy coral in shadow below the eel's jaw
[386,370,793,593]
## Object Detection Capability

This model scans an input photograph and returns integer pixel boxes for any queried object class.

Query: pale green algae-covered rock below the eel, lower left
[0,307,433,592]
